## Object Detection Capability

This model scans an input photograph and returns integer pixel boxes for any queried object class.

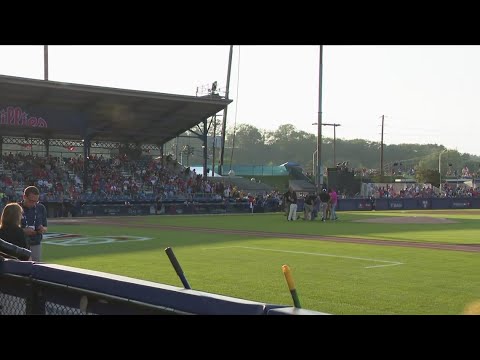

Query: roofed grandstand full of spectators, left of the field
[0,76,290,217]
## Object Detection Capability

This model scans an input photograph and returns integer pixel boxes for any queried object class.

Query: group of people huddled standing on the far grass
[283,187,338,222]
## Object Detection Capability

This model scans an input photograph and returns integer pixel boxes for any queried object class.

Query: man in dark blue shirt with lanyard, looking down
[20,186,47,261]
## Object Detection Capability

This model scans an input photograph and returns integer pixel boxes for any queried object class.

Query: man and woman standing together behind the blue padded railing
[0,186,47,261]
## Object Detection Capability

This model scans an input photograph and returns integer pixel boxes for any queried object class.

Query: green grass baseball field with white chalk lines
[43,210,480,314]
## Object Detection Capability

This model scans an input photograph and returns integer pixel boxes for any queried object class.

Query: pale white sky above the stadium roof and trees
[0,45,480,155]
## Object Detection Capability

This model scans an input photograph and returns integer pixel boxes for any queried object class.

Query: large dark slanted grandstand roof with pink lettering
[0,75,232,145]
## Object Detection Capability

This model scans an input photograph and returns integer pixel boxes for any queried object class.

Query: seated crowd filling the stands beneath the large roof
[0,152,280,214]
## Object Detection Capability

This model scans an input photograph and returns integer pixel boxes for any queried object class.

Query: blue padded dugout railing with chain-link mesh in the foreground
[0,258,327,315]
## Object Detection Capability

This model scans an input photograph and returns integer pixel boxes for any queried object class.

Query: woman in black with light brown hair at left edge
[0,203,30,260]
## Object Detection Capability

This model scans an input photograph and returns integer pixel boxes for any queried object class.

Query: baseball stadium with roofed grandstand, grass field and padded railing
[0,76,480,315]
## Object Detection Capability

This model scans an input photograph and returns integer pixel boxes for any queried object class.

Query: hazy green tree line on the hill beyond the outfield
[165,124,480,176]
